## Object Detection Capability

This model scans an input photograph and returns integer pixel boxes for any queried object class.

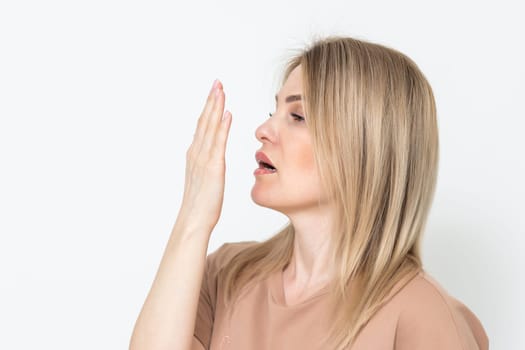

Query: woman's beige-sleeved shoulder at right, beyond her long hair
[391,271,488,350]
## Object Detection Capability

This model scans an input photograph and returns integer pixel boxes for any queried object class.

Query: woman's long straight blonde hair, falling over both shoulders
[220,36,439,349]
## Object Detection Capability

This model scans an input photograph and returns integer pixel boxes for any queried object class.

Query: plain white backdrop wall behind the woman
[0,0,525,350]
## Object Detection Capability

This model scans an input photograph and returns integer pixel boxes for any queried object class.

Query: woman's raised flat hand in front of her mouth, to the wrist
[177,80,231,234]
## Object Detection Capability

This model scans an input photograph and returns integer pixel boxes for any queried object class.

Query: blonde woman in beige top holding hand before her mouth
[130,36,488,350]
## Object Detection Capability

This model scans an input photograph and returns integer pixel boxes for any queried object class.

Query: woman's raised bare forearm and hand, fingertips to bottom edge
[129,81,232,350]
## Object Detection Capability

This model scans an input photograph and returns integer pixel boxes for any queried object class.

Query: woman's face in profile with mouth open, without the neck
[251,65,321,216]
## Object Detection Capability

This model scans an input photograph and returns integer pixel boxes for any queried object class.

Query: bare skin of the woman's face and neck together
[251,65,333,305]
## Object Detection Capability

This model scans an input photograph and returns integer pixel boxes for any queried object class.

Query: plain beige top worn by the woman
[194,241,488,350]
